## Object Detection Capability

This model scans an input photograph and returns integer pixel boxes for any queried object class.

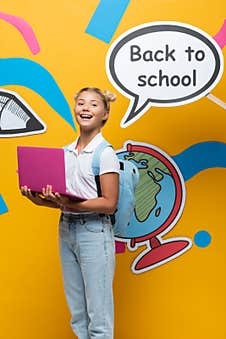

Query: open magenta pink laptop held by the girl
[17,146,84,200]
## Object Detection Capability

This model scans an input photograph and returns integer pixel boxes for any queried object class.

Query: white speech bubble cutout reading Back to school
[106,21,224,127]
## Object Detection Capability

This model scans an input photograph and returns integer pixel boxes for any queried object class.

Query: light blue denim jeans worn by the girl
[59,214,115,339]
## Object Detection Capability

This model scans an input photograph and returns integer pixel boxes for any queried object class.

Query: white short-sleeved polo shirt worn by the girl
[64,133,119,199]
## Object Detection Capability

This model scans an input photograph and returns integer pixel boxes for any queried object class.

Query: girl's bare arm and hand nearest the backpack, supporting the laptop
[43,172,119,214]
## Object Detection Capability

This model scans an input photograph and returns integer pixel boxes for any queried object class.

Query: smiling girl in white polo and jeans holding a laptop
[21,87,119,339]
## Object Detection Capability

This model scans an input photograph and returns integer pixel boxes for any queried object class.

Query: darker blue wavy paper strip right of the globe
[171,141,226,181]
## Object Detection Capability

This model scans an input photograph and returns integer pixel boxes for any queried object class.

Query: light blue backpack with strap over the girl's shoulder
[92,140,139,238]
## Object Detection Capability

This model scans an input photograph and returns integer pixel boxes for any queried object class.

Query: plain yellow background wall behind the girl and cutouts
[0,0,226,339]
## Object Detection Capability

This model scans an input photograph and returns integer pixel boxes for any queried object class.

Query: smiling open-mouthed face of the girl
[74,90,109,131]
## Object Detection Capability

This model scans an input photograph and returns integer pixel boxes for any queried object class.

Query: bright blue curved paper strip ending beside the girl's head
[0,58,75,130]
